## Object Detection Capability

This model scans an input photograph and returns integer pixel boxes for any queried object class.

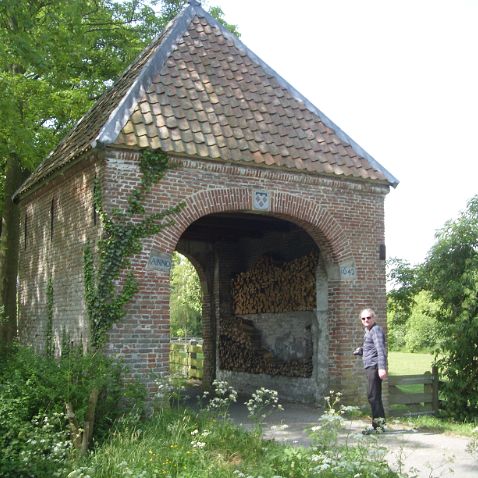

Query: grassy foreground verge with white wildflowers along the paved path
[69,410,398,478]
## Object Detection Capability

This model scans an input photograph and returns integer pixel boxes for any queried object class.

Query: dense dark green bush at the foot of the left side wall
[0,346,143,478]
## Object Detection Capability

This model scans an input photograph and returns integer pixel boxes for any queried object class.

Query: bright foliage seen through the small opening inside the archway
[170,253,202,337]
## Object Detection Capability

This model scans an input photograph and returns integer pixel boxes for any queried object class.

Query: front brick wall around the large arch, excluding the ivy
[105,148,388,402]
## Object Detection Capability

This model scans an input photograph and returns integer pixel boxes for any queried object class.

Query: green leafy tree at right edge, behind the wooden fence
[389,195,478,418]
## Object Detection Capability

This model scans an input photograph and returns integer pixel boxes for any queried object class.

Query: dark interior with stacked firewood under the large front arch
[173,212,328,401]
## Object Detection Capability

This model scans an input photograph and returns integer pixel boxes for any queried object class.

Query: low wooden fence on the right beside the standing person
[388,367,439,416]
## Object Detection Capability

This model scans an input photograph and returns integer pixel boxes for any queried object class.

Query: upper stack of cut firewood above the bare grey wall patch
[232,252,318,315]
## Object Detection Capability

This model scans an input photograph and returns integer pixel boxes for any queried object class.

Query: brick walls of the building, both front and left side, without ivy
[20,150,388,406]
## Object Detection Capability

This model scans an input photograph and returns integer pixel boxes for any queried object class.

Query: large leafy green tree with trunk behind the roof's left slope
[0,0,236,347]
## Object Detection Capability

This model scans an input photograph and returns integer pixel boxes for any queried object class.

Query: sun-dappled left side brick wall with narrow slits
[18,155,100,352]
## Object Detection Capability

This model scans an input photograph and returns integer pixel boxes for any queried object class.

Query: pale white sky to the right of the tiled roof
[210,0,478,264]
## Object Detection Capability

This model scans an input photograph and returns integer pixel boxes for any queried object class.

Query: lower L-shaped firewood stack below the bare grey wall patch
[219,318,312,377]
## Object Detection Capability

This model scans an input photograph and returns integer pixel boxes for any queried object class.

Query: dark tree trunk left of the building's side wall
[0,155,28,352]
